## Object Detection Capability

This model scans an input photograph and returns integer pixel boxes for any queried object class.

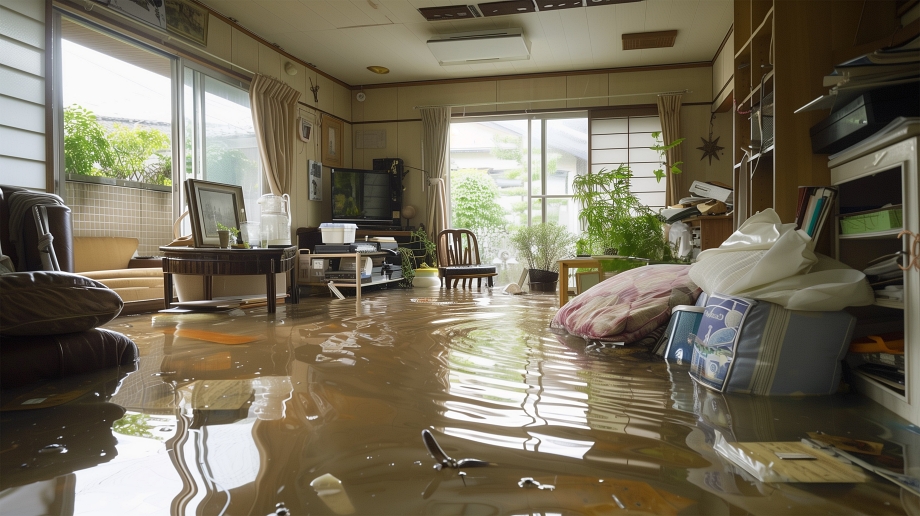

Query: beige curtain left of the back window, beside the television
[419,107,450,240]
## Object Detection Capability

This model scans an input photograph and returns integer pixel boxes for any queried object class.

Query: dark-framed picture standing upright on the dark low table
[185,179,245,247]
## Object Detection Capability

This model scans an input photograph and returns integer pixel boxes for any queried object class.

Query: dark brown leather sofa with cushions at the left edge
[0,185,138,389]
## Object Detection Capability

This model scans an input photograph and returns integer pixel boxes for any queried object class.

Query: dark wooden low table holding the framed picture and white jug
[160,246,299,313]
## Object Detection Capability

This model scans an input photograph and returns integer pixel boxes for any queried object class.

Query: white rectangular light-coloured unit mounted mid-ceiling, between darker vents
[428,29,530,66]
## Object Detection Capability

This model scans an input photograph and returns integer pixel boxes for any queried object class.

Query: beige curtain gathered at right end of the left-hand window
[249,74,300,195]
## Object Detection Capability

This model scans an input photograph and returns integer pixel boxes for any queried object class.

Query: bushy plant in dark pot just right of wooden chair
[511,222,575,292]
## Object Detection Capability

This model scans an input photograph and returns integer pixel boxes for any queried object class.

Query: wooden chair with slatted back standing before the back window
[436,229,498,289]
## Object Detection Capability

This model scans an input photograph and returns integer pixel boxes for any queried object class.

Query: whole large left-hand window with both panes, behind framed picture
[55,14,263,255]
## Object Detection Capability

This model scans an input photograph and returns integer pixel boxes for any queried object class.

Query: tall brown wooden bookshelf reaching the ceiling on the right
[733,0,858,235]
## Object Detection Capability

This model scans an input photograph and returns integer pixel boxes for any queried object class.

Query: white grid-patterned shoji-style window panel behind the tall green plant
[591,112,667,213]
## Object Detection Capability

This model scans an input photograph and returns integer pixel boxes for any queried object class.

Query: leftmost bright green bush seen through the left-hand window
[64,104,114,176]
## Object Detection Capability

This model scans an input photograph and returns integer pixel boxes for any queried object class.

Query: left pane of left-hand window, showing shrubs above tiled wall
[57,16,176,256]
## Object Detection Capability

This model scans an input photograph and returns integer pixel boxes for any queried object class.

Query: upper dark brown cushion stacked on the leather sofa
[0,271,124,336]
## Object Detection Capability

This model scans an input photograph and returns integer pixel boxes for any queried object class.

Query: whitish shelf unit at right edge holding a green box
[829,119,920,424]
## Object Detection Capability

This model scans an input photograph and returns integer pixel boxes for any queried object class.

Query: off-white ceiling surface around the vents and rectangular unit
[203,0,732,86]
